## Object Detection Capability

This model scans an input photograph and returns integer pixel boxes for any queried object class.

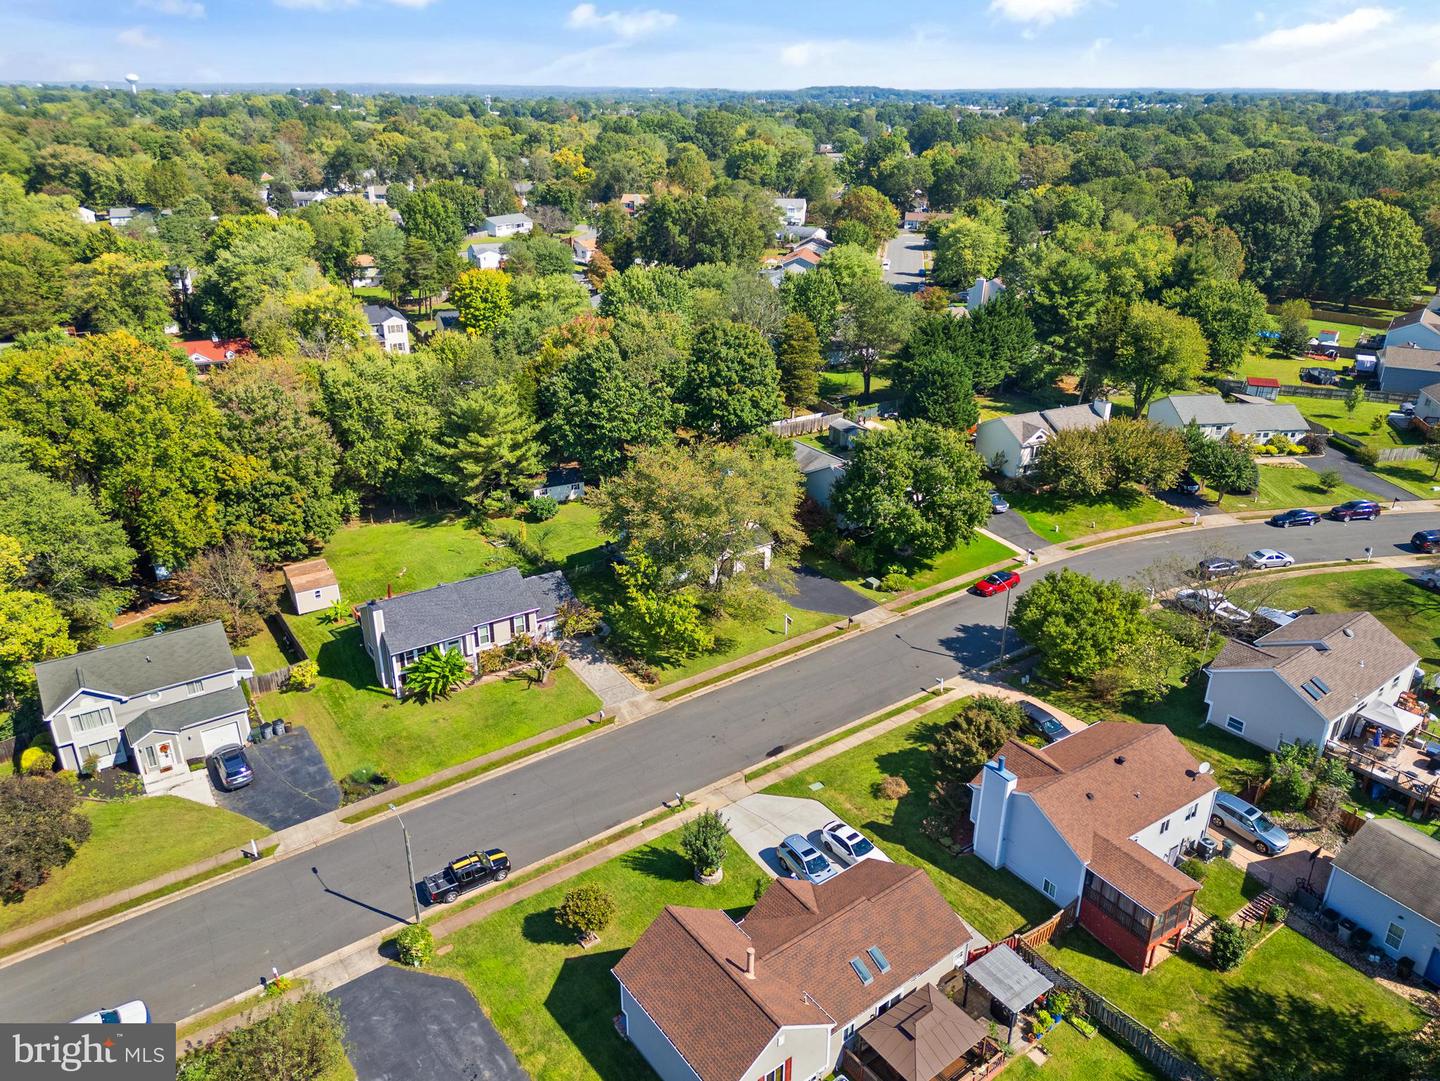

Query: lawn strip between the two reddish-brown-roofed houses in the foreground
[766,714,1056,940]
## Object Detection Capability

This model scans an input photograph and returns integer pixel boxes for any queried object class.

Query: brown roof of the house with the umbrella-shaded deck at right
[1210,612,1420,720]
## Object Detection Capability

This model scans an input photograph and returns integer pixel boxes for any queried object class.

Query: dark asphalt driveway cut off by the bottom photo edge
[330,964,528,1081]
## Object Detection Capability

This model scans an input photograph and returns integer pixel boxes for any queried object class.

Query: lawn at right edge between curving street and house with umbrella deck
[1237,567,1440,671]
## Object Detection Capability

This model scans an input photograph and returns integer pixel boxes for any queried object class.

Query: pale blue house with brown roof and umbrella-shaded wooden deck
[1205,612,1420,750]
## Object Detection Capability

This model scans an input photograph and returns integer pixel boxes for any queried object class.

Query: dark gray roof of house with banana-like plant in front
[370,567,570,655]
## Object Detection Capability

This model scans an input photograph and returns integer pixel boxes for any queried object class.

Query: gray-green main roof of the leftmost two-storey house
[35,622,235,717]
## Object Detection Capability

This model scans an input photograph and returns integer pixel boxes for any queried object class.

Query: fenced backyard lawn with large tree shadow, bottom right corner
[1043,928,1424,1081]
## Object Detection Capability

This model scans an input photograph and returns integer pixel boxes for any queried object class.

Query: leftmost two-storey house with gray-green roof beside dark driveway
[35,622,255,795]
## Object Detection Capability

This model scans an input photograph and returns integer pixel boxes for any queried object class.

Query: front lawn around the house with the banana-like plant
[256,623,600,784]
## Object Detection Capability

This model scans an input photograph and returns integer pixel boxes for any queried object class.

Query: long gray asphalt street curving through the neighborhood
[0,512,1440,1021]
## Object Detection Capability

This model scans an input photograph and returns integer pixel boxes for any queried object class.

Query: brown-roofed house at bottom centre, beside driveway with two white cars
[612,859,976,1081]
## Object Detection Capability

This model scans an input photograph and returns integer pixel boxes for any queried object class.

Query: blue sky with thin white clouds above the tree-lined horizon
[0,0,1440,89]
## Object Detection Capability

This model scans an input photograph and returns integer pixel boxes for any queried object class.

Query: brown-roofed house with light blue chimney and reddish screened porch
[971,721,1218,972]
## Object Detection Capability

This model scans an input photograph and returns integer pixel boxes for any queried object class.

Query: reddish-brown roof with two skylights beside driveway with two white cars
[615,859,973,1081]
